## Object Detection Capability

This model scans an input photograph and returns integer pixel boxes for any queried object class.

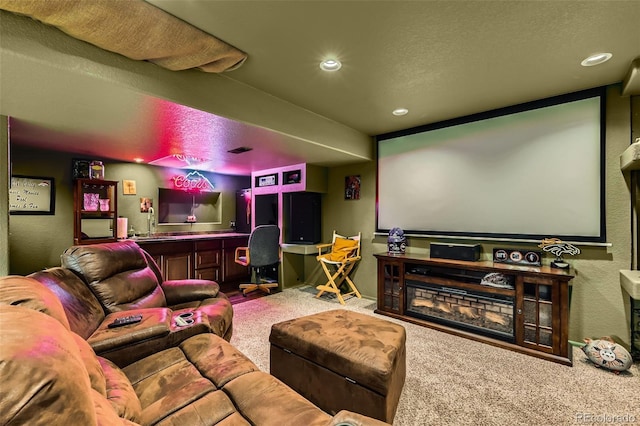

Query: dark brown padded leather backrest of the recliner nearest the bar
[61,241,167,312]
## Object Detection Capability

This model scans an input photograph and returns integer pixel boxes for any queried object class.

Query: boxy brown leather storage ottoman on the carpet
[269,309,406,423]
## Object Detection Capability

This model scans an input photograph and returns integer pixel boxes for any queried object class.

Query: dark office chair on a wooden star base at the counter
[235,225,280,296]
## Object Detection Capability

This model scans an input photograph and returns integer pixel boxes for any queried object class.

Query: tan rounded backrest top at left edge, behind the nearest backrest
[0,275,69,330]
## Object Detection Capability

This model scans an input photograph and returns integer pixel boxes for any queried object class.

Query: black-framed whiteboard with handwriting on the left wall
[9,175,55,214]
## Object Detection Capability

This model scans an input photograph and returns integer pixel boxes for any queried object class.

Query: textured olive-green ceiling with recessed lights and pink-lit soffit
[0,0,640,174]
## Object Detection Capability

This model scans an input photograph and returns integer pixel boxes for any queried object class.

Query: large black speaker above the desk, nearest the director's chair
[284,192,322,244]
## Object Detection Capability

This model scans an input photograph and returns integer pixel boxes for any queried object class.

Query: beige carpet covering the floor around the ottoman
[231,287,640,426]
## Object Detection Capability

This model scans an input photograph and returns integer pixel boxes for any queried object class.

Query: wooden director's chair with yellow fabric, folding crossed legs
[316,231,362,305]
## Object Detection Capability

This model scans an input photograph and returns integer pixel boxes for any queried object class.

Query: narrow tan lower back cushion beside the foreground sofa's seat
[97,357,142,422]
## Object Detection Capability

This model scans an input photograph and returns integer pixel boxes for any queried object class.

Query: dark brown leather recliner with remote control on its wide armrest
[29,241,233,367]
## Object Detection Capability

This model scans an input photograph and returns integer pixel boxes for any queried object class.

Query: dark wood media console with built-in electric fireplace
[374,253,573,365]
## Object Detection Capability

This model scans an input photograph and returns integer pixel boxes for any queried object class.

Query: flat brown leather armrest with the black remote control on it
[87,308,171,354]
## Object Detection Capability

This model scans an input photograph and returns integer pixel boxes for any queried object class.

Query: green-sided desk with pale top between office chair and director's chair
[280,244,318,289]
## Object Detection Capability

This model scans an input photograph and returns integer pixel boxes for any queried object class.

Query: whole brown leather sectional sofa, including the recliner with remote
[0,243,386,426]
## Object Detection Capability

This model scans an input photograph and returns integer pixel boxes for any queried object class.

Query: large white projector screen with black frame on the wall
[376,89,605,242]
